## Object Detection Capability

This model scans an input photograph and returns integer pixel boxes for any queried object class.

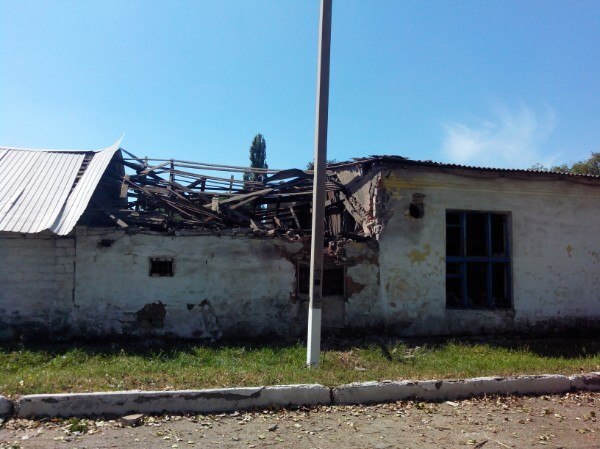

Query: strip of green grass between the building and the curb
[0,338,600,396]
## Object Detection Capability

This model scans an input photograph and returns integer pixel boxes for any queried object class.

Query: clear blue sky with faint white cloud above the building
[0,0,600,168]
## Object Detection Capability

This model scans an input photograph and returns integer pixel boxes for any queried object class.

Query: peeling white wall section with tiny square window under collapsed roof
[73,228,305,339]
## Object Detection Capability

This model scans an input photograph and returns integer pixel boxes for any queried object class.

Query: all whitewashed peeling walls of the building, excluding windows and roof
[0,169,600,340]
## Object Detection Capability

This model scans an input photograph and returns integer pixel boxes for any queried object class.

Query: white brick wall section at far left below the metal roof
[0,232,75,341]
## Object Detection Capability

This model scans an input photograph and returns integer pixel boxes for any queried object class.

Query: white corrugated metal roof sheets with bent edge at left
[0,139,121,235]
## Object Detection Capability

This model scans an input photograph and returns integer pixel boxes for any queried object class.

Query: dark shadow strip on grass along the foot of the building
[0,336,600,361]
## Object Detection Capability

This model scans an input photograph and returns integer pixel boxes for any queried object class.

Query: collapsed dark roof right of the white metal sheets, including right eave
[113,150,600,239]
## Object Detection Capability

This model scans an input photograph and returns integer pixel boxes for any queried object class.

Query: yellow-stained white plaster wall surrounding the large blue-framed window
[379,169,600,335]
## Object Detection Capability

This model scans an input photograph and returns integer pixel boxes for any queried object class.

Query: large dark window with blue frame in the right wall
[446,210,512,309]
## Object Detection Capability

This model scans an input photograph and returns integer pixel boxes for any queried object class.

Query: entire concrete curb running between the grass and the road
[5,372,600,418]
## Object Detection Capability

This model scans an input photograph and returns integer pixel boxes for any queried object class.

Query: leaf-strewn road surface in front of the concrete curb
[0,393,600,449]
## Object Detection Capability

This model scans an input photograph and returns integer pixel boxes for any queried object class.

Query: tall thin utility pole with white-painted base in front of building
[306,0,332,367]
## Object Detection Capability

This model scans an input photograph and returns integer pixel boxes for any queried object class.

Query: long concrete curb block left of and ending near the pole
[15,385,331,418]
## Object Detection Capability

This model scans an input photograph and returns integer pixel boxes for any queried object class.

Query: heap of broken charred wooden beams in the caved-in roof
[113,151,366,235]
